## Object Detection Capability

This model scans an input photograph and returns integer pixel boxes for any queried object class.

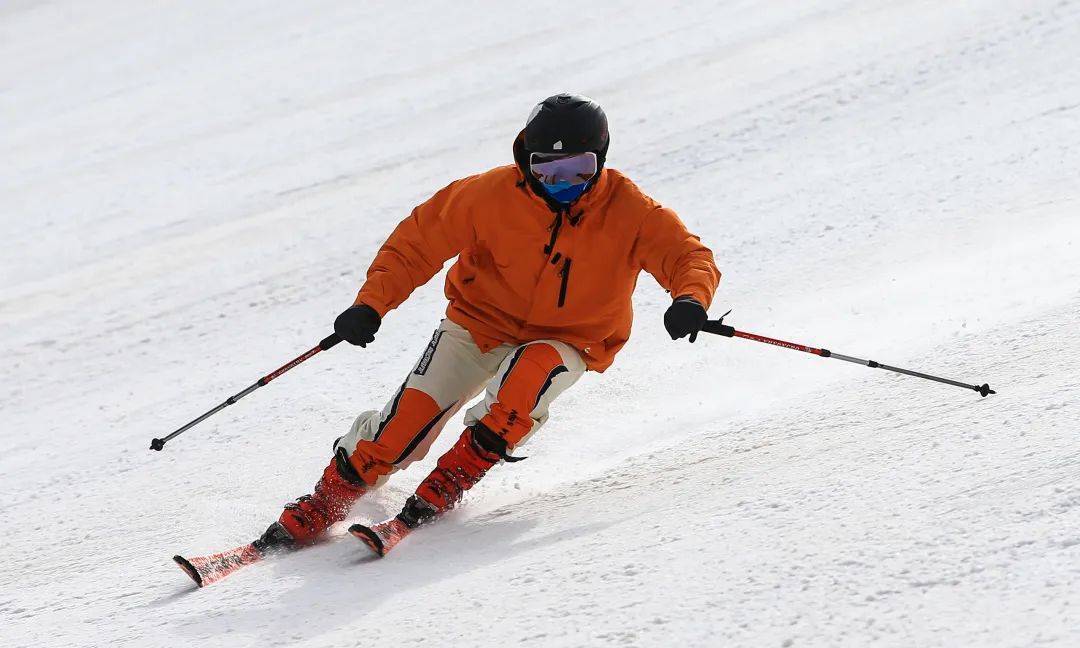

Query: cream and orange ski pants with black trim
[334,320,585,486]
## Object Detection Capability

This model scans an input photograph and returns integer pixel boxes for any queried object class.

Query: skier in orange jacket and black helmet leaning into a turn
[260,94,720,545]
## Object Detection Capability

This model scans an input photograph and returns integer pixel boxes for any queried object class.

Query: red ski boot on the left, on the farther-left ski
[278,453,367,544]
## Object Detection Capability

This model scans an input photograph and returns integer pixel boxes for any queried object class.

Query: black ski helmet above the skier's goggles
[525,93,610,173]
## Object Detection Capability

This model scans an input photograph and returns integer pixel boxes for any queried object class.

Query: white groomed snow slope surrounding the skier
[0,0,1080,647]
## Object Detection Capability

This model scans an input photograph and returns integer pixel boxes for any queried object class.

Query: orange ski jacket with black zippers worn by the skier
[355,135,720,372]
